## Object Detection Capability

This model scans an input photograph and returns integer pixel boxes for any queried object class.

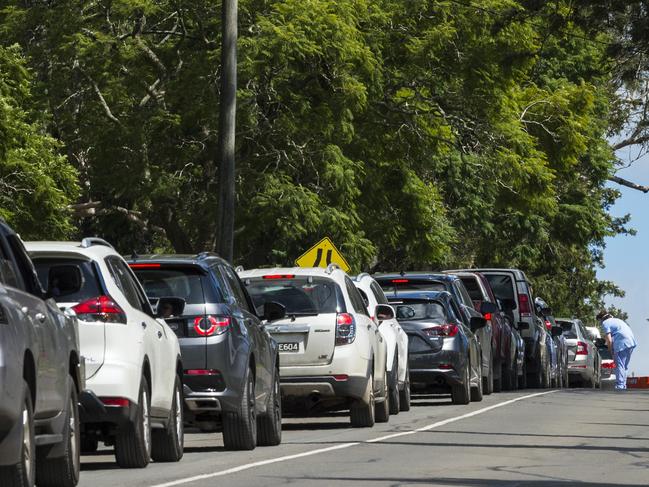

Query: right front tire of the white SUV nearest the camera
[151,376,185,462]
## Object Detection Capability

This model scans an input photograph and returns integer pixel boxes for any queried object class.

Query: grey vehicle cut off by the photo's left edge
[0,220,84,487]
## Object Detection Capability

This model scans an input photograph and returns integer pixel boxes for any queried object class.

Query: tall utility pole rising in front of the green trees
[216,0,237,262]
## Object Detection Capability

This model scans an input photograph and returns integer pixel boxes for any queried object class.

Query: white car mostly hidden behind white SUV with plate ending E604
[354,273,410,414]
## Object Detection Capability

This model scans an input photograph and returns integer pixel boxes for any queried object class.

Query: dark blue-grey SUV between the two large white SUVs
[129,252,285,450]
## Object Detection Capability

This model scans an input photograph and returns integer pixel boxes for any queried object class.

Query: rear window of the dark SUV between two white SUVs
[132,265,214,304]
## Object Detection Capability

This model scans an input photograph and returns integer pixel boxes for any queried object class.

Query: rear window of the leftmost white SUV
[32,257,104,303]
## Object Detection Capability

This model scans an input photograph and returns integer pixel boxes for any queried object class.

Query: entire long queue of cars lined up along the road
[0,221,612,487]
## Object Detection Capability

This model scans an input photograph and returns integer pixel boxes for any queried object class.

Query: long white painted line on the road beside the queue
[152,390,557,487]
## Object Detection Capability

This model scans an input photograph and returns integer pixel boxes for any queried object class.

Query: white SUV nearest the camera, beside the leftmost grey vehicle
[26,238,184,468]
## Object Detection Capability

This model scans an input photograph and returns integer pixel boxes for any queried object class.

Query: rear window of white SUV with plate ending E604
[244,276,339,315]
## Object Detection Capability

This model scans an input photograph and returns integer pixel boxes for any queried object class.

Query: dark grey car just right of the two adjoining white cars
[378,291,486,404]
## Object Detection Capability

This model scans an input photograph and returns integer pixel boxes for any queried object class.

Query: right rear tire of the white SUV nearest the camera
[115,376,151,468]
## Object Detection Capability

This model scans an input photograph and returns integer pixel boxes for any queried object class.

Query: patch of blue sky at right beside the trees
[597,155,649,376]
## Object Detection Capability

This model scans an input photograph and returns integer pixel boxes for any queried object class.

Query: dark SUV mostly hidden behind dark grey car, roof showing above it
[375,272,498,394]
